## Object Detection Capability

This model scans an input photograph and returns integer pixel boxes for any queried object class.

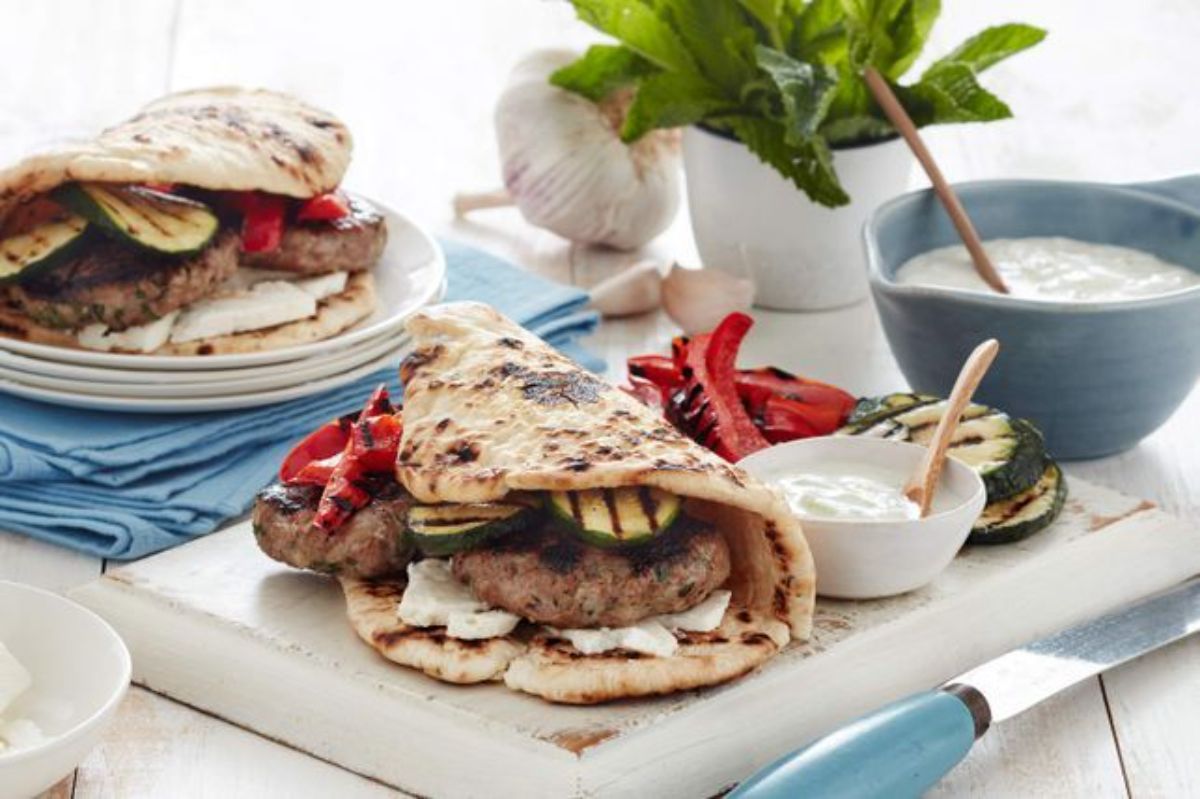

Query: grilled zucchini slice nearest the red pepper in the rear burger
[53,184,220,256]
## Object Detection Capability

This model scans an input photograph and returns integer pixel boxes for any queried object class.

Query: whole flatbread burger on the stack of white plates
[0,88,388,355]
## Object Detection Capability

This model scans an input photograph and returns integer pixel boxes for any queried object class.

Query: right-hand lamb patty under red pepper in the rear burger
[241,194,388,275]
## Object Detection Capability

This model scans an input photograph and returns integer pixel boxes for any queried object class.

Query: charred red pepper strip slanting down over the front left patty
[313,385,401,533]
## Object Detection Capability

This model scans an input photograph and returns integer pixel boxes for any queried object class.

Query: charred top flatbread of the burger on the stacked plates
[0,86,352,224]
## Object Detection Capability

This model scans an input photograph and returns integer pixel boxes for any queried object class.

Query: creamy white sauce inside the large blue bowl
[896,238,1200,302]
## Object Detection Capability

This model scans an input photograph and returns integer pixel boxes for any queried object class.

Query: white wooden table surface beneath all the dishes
[0,0,1200,798]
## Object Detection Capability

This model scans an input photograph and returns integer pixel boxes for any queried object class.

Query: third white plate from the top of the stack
[0,335,407,400]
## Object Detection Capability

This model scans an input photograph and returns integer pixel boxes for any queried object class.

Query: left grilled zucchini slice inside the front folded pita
[408,503,538,558]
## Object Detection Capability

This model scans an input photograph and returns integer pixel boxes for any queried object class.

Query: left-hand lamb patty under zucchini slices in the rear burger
[0,230,239,330]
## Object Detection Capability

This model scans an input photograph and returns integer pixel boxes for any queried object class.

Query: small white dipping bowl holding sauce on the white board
[738,435,988,599]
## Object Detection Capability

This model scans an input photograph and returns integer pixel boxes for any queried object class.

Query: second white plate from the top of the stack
[0,331,404,388]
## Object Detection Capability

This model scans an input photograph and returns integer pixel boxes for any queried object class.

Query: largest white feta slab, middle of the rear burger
[170,281,317,342]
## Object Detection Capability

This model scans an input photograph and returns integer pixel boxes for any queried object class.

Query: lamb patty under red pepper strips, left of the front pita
[251,475,413,577]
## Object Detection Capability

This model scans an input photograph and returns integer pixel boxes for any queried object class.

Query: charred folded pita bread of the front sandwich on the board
[348,302,815,703]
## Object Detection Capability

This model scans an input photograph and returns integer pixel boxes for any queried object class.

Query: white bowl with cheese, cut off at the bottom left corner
[0,581,131,799]
